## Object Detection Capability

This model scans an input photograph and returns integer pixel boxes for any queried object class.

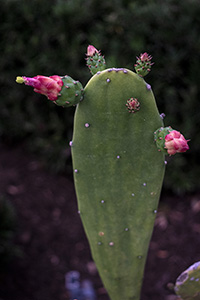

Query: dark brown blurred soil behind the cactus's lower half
[0,145,200,300]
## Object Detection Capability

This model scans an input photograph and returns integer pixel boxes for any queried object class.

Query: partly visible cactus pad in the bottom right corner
[174,262,200,300]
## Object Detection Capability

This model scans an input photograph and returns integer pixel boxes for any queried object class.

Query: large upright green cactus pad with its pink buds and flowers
[17,45,188,300]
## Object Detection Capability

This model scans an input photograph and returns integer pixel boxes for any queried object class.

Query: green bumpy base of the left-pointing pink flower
[55,75,83,107]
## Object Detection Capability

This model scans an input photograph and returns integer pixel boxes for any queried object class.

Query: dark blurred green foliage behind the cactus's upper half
[0,0,200,192]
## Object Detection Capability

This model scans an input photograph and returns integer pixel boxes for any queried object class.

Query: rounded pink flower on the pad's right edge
[165,130,189,155]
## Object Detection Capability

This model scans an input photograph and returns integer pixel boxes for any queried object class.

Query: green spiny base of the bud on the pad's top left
[87,51,106,75]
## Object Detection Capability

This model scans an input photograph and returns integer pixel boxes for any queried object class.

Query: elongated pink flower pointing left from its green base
[22,75,63,101]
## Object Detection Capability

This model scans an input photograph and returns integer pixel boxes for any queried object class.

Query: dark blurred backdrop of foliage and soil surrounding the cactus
[0,0,200,300]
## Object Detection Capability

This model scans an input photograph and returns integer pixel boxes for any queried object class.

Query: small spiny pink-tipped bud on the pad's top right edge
[135,52,153,77]
